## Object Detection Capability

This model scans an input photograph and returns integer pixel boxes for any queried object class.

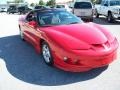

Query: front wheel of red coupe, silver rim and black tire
[42,42,53,66]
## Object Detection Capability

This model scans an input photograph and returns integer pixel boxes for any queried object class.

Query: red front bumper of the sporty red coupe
[53,39,119,72]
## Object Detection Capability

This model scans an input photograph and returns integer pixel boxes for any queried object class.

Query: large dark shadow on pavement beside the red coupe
[0,35,107,86]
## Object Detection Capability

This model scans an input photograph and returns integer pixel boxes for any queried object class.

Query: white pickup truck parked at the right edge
[95,0,120,22]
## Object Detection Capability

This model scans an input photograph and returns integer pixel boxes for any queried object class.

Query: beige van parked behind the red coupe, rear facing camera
[73,0,94,21]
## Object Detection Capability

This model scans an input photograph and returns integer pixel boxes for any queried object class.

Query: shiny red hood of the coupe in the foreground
[43,23,113,49]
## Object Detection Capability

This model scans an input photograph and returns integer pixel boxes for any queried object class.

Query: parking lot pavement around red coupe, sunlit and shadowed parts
[0,13,120,90]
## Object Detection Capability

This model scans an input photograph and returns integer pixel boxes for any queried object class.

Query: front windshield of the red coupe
[38,11,83,26]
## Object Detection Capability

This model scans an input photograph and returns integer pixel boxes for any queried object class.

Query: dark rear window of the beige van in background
[74,2,92,9]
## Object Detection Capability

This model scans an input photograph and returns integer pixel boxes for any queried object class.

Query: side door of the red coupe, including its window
[24,12,41,46]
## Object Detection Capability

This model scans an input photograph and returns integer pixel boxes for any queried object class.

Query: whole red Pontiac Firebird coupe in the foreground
[19,9,118,72]
